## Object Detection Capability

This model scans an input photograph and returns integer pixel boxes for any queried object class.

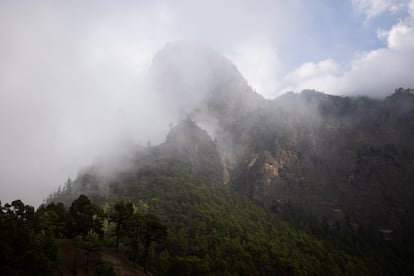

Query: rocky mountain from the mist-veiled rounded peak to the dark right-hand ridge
[146,43,414,237]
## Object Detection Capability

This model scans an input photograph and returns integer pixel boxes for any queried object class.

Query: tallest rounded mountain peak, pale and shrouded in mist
[150,41,264,124]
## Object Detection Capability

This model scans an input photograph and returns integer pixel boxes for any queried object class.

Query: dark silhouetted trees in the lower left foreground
[0,195,167,275]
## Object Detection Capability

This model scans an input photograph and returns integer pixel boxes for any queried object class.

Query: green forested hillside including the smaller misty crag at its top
[50,118,411,275]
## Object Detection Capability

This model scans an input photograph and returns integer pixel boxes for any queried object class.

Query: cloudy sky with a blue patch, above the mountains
[0,0,414,205]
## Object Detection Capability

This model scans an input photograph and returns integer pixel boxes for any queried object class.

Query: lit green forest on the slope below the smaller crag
[102,173,406,275]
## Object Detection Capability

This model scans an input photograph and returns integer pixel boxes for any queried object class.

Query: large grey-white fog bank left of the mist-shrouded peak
[0,1,179,204]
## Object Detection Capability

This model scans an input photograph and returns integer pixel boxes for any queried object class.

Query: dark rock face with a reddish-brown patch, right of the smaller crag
[231,90,414,238]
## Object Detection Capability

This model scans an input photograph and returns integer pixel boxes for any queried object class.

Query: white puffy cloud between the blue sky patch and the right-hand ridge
[278,1,414,97]
